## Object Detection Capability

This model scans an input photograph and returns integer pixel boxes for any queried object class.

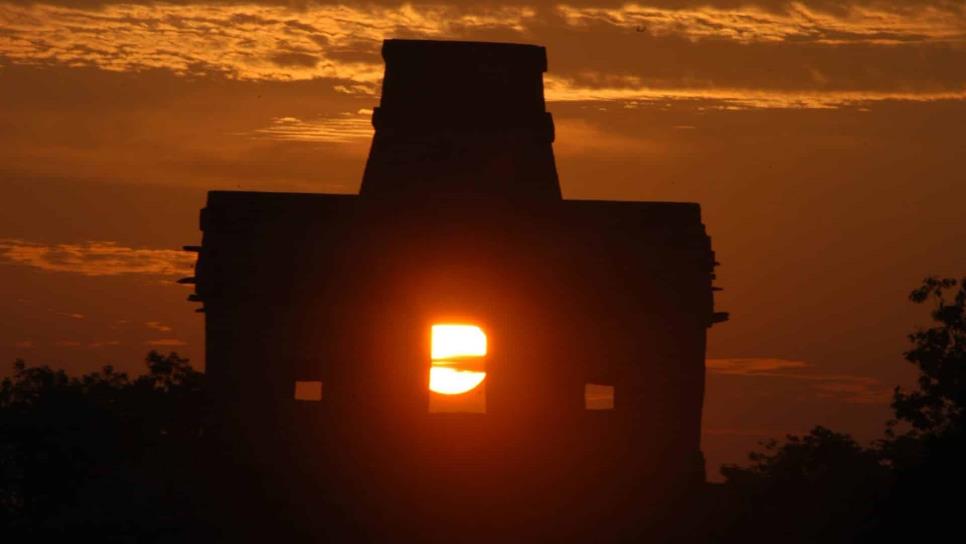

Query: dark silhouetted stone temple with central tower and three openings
[184,40,727,542]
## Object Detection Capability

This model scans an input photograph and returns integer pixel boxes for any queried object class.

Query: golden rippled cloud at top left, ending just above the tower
[0,3,535,82]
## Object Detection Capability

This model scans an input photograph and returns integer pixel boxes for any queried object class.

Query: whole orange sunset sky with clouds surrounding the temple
[0,0,966,476]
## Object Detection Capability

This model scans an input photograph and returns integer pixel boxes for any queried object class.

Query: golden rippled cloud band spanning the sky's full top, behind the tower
[0,1,966,110]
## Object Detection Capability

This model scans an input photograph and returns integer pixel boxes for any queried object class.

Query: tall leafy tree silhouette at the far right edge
[874,278,966,541]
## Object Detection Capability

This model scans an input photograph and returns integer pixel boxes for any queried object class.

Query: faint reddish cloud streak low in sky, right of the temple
[706,357,892,404]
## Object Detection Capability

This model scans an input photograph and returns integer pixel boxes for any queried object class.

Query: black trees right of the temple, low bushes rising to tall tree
[711,278,966,542]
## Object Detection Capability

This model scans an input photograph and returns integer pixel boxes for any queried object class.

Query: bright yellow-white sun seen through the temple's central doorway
[429,324,486,395]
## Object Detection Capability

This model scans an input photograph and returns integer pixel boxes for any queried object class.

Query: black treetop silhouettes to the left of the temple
[0,351,205,540]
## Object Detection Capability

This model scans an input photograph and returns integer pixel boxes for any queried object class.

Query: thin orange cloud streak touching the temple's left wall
[0,239,195,276]
